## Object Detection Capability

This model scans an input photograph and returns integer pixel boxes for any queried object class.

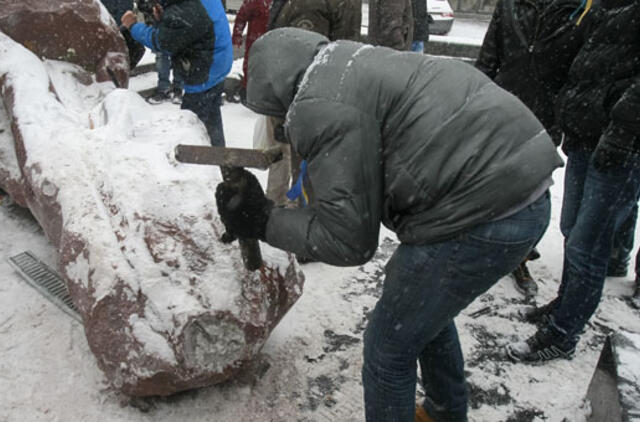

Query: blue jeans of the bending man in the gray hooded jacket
[362,192,551,422]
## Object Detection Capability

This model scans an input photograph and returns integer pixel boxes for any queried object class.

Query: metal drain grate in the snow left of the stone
[9,251,82,322]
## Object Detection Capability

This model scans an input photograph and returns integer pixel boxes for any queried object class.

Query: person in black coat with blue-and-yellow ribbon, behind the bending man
[476,0,593,300]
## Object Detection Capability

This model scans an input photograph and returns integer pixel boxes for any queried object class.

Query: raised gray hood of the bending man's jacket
[247,28,329,117]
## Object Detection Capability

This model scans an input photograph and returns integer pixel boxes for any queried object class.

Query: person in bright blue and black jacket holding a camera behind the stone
[121,0,233,146]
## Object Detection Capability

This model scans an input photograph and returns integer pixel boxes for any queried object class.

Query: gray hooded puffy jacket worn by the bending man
[247,28,562,265]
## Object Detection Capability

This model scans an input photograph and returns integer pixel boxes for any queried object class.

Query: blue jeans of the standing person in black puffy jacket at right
[551,151,640,341]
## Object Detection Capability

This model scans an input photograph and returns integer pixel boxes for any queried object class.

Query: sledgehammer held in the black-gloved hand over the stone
[175,145,282,271]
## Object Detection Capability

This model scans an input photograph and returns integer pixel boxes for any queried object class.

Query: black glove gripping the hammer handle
[216,168,273,243]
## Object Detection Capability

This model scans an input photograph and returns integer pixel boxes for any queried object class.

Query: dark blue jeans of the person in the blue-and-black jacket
[181,81,225,147]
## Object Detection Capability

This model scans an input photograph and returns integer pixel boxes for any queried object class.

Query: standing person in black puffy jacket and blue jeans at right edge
[507,0,640,362]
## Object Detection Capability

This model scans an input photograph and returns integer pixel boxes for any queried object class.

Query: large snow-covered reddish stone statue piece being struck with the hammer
[0,33,303,396]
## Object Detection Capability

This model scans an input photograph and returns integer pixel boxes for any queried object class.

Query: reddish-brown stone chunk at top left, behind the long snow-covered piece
[0,0,129,87]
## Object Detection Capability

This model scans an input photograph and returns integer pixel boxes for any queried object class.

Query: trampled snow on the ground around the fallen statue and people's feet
[0,77,640,422]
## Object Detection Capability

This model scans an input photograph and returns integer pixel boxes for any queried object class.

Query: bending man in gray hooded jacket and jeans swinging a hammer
[216,28,562,422]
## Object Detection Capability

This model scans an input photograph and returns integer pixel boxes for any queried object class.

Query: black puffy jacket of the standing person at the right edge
[556,0,640,157]
